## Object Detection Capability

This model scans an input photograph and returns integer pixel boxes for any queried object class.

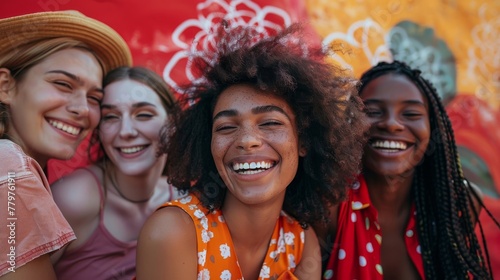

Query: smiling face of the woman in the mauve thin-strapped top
[99,79,167,175]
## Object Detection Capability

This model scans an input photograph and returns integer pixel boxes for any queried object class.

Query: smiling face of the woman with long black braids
[360,74,430,175]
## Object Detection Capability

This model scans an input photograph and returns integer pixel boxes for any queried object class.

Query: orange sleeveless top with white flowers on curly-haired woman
[162,195,304,280]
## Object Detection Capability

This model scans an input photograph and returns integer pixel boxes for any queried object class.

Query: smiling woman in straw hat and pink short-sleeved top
[0,11,132,280]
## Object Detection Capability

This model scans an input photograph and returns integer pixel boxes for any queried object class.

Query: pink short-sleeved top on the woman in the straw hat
[0,139,75,276]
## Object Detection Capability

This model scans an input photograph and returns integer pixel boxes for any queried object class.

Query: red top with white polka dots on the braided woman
[323,175,425,280]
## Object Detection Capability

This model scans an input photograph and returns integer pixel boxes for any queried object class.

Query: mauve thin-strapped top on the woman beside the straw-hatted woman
[54,169,137,280]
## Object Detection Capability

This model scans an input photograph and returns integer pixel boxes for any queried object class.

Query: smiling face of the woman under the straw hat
[2,48,103,166]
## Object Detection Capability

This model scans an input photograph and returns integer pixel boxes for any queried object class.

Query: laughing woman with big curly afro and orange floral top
[137,24,365,280]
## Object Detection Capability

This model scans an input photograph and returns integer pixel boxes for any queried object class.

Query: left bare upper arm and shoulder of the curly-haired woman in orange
[136,207,198,280]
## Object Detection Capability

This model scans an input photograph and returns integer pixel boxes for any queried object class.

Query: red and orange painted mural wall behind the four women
[0,0,500,277]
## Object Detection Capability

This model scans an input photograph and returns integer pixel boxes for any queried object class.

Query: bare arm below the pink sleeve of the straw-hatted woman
[0,254,57,280]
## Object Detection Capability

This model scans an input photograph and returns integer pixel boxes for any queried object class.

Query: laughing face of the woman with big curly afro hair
[211,85,302,204]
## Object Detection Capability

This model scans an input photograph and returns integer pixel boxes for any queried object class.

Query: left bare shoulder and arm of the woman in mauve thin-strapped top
[51,166,101,264]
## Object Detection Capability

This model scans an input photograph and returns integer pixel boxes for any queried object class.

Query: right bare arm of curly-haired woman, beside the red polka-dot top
[294,227,321,279]
